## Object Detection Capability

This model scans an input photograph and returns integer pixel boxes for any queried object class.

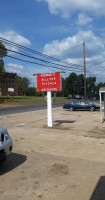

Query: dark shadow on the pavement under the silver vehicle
[0,153,27,176]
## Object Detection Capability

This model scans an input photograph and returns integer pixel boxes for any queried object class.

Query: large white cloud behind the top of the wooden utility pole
[44,30,105,57]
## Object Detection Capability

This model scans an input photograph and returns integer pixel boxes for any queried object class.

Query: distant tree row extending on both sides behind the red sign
[18,72,105,99]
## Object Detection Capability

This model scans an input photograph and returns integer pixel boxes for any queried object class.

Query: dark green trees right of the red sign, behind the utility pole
[62,73,101,99]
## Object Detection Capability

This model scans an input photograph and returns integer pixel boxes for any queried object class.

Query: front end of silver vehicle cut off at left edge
[0,127,13,164]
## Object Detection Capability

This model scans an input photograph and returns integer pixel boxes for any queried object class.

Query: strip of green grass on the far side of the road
[0,96,70,105]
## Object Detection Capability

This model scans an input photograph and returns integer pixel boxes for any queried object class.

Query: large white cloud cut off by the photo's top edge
[36,0,105,22]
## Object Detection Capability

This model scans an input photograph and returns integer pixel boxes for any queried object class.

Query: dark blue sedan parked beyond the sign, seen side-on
[63,101,100,111]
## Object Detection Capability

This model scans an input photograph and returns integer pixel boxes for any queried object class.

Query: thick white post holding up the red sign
[47,91,53,127]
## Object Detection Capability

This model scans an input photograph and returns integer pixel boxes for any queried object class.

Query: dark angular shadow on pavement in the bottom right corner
[90,176,105,200]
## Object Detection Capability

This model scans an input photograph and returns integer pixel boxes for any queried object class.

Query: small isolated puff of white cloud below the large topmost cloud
[77,13,93,25]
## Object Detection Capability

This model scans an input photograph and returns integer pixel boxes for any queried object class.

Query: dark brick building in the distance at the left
[0,72,18,96]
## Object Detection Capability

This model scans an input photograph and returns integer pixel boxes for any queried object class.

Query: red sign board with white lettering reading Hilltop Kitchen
[37,72,62,92]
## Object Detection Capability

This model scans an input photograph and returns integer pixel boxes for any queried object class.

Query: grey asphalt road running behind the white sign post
[0,103,63,115]
